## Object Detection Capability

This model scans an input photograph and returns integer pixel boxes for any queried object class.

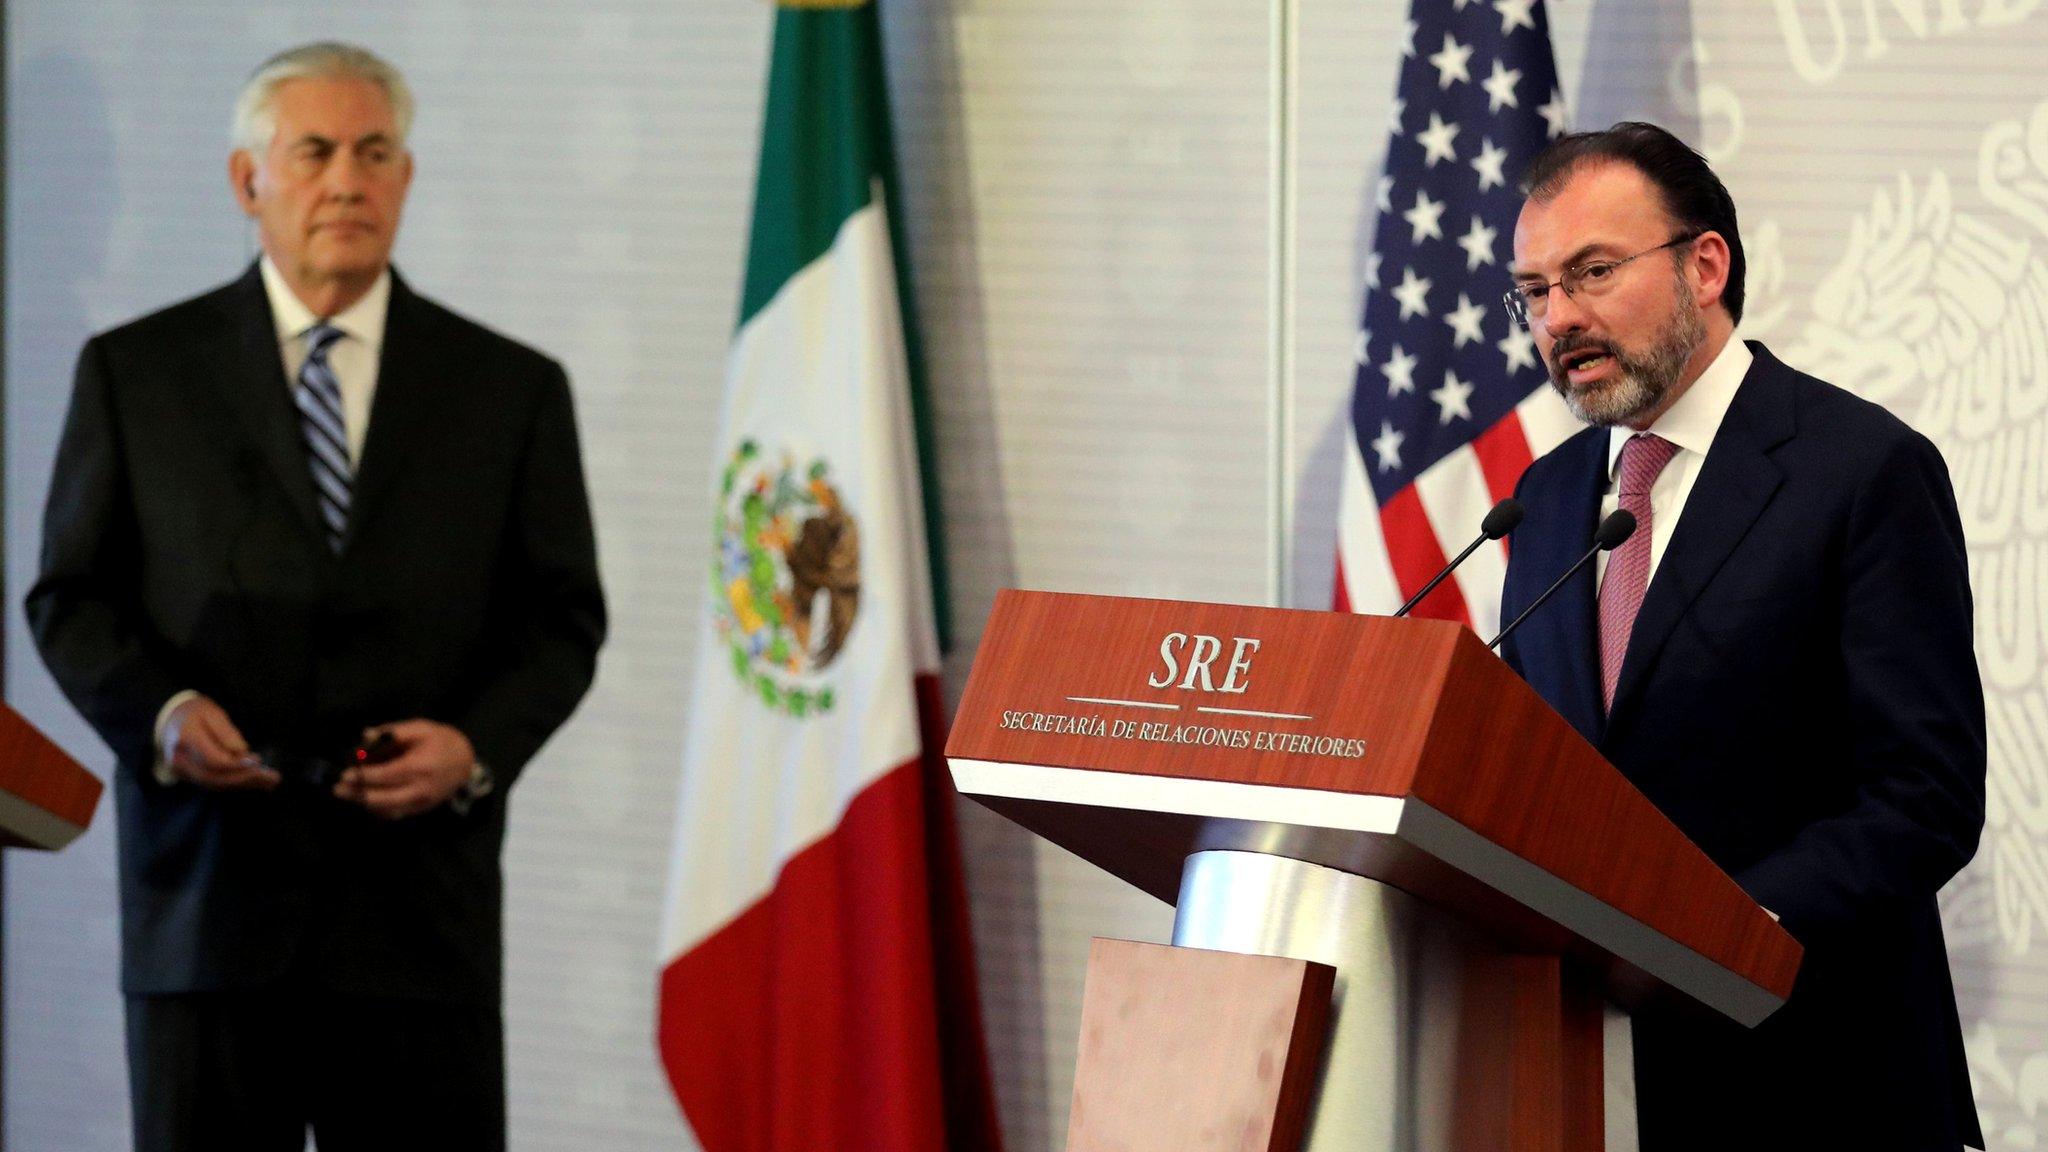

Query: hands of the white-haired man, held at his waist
[164,695,477,820]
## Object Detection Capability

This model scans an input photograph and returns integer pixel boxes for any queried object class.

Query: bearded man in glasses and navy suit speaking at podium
[1501,125,1985,1152]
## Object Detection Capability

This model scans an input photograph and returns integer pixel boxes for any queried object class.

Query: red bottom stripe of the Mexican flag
[657,678,1001,1152]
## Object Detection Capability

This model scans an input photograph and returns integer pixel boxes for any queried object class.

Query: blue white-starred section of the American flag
[1352,0,1565,506]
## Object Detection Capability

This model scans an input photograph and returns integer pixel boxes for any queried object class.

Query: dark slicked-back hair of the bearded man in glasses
[1522,121,1747,320]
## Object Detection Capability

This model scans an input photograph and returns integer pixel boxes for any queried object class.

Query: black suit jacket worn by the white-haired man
[27,266,604,1004]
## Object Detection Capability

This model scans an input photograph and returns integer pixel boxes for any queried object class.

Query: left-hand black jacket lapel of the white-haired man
[201,264,319,535]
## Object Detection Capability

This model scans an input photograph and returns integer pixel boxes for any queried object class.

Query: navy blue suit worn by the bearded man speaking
[1501,344,1985,1152]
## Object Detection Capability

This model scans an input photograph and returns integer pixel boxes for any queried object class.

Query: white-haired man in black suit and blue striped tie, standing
[27,45,604,1152]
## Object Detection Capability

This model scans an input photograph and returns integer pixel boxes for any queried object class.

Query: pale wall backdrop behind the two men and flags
[4,0,2048,1152]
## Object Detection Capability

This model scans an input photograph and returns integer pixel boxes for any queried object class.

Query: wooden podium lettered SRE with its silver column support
[946,590,1800,1152]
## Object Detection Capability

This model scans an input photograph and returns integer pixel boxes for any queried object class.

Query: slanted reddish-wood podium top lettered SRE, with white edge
[946,590,1800,1023]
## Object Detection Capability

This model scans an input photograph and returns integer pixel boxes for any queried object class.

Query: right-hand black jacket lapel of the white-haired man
[344,271,453,551]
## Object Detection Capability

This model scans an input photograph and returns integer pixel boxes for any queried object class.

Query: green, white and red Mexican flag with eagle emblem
[657,2,999,1152]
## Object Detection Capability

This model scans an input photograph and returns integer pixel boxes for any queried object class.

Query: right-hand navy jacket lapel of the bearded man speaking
[1614,344,1792,713]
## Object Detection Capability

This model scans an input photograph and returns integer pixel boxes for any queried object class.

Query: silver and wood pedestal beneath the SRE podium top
[1174,851,1634,1152]
